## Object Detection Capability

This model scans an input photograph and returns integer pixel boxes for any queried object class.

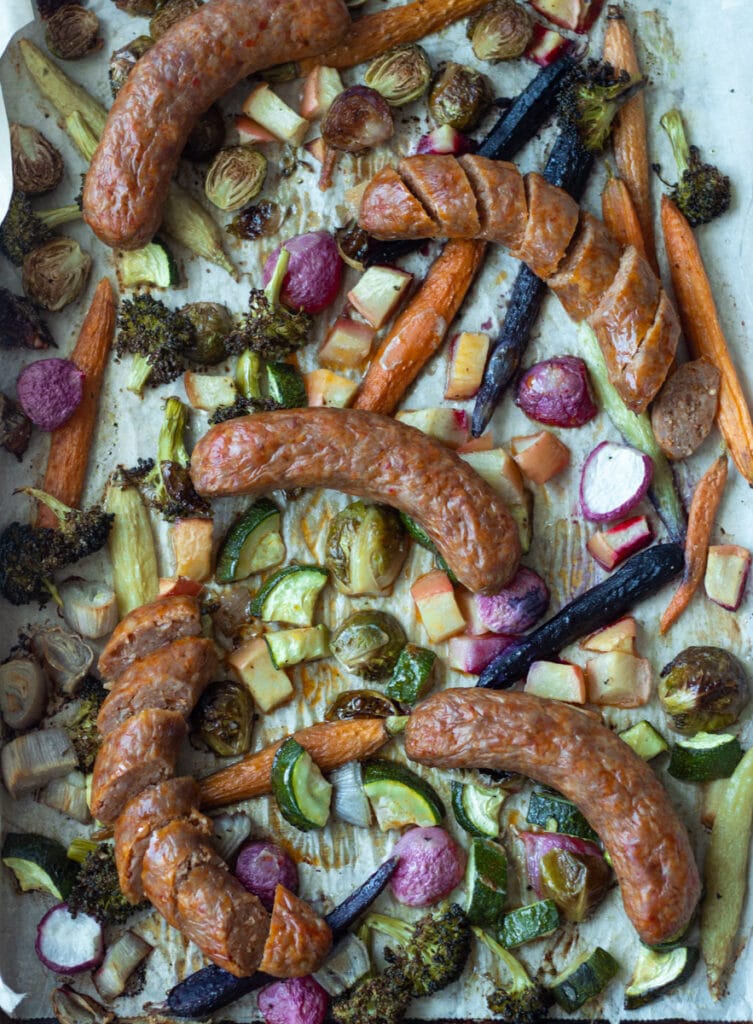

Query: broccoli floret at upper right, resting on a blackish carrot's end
[558,60,645,153]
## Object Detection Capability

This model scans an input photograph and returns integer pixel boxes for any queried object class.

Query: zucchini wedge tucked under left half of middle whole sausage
[215,498,285,583]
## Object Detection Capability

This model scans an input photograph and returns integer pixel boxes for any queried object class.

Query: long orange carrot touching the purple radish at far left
[37,278,115,526]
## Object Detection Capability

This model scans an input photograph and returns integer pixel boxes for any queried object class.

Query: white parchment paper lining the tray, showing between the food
[0,0,753,1021]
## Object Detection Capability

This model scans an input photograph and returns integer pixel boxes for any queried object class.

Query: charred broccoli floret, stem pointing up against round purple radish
[226,248,312,359]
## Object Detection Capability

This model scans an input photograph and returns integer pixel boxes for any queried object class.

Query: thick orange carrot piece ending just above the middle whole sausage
[353,239,486,415]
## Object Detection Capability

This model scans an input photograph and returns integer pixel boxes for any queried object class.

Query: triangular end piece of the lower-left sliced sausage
[260,886,332,978]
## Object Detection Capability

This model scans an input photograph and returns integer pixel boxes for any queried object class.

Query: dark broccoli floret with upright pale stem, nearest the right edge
[661,110,731,227]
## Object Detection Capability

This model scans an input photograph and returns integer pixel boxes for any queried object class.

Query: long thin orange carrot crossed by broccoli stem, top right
[603,4,659,273]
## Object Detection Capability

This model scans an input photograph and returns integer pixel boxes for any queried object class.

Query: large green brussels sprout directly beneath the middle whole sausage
[326,502,408,594]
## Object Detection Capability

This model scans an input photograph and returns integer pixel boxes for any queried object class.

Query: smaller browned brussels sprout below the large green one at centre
[330,608,406,681]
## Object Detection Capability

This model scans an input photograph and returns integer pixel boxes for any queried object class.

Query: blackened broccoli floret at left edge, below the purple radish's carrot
[0,487,113,604]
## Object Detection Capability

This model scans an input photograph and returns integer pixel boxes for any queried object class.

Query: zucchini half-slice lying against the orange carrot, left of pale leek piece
[271,736,332,831]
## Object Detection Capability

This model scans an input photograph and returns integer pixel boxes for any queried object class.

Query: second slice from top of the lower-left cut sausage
[96,637,217,736]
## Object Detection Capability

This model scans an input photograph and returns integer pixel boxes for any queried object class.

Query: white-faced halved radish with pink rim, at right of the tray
[580,441,654,522]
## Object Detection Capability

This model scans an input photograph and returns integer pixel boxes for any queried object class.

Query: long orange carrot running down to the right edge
[662,196,753,485]
